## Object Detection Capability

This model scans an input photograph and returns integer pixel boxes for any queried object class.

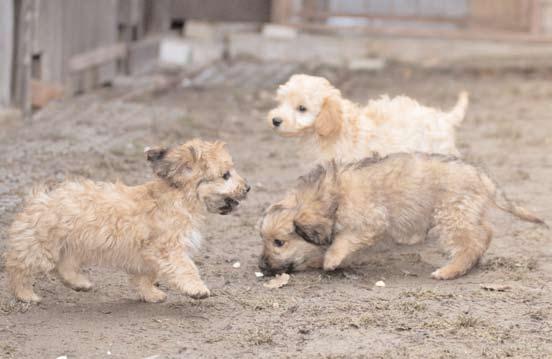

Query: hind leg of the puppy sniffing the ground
[431,223,492,279]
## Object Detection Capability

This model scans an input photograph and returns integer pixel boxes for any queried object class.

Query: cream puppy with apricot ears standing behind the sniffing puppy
[268,75,468,161]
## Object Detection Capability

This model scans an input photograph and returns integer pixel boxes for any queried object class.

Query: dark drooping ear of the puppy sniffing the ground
[293,210,333,246]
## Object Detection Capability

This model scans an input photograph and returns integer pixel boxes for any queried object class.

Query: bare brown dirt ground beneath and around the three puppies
[0,62,552,358]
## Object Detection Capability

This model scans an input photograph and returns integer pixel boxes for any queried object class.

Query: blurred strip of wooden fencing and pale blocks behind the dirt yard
[0,0,552,114]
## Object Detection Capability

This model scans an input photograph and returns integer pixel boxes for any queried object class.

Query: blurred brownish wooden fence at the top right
[272,0,552,42]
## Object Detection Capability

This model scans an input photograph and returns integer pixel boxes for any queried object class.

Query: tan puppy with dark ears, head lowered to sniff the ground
[259,153,544,279]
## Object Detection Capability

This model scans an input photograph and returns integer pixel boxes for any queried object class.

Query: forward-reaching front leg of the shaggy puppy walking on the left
[159,249,210,299]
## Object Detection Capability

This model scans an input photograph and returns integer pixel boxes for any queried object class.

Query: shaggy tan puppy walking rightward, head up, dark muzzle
[5,139,250,302]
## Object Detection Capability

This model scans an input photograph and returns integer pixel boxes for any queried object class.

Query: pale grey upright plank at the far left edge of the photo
[0,0,15,107]
